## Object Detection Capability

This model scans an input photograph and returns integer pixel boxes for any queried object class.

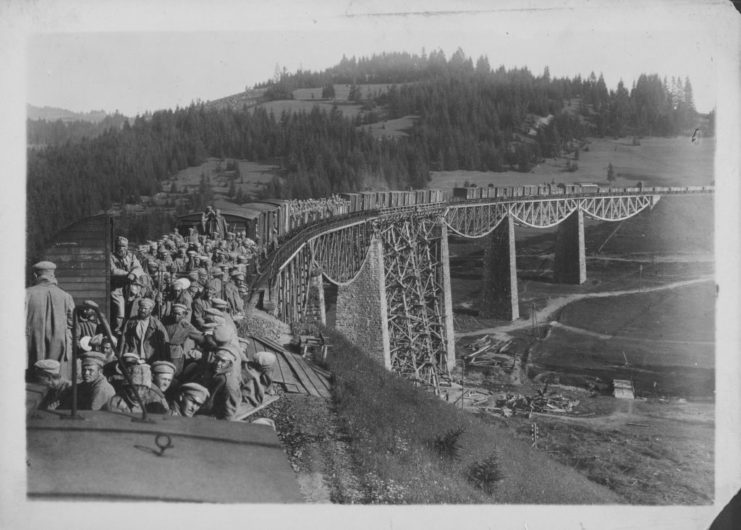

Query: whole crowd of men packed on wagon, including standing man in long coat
[26,212,276,420]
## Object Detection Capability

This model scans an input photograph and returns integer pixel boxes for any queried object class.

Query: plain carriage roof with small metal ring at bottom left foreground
[26,411,303,503]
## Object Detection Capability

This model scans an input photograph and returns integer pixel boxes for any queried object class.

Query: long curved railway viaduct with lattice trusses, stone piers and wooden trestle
[255,188,712,384]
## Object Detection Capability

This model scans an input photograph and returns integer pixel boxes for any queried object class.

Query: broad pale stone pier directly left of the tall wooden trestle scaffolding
[335,238,391,370]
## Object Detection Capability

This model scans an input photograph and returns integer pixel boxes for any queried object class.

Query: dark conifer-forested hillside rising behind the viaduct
[27,50,696,257]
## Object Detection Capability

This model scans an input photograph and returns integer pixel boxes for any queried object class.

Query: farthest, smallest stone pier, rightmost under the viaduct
[553,209,587,285]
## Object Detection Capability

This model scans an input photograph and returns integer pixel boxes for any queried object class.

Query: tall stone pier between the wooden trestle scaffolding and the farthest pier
[481,215,520,320]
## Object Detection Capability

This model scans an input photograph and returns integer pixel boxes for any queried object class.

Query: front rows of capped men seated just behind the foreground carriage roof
[31,325,276,420]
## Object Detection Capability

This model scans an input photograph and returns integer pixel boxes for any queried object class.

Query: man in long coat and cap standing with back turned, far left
[26,261,75,378]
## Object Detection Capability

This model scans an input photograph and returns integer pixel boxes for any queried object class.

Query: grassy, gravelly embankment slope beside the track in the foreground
[258,329,625,504]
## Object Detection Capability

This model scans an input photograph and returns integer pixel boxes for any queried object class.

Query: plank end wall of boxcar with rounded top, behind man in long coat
[44,215,113,316]
